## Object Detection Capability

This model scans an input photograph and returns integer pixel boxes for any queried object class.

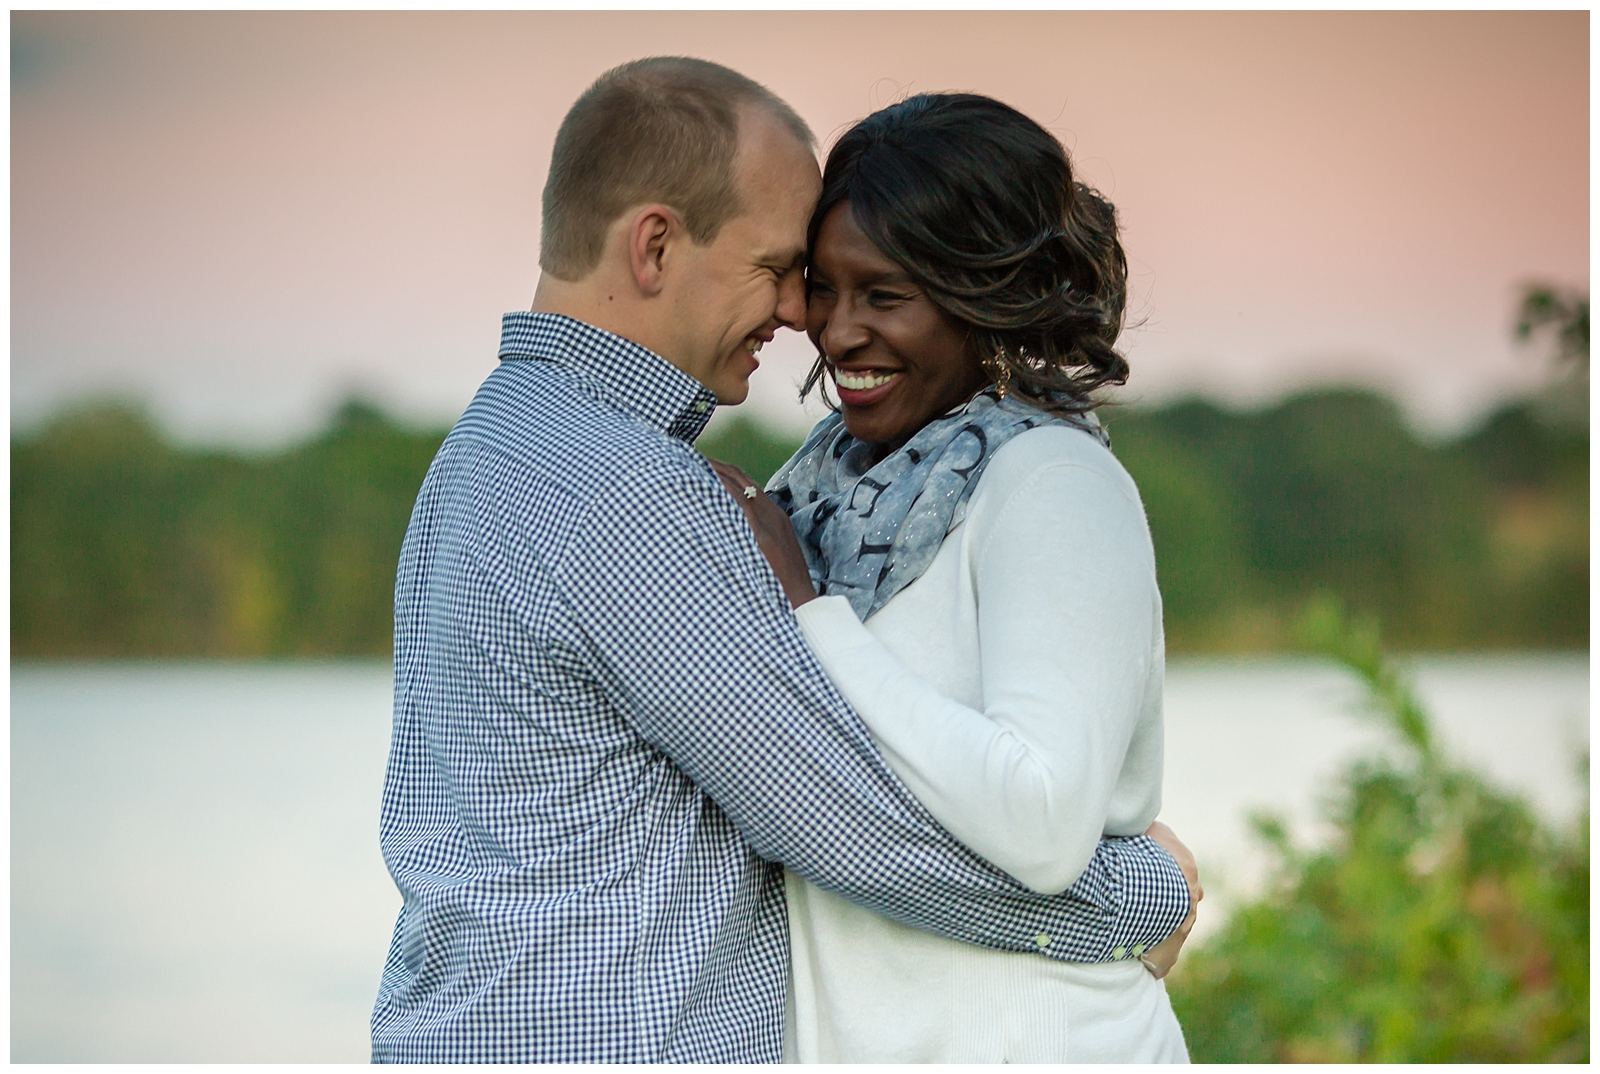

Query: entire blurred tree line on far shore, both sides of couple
[11,391,1589,656]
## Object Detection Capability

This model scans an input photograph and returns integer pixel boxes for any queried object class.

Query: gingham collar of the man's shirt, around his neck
[499,311,717,443]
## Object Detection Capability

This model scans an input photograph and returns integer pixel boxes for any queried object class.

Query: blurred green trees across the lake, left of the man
[11,403,445,656]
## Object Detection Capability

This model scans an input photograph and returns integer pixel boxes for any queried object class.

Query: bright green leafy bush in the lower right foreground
[1168,599,1589,1063]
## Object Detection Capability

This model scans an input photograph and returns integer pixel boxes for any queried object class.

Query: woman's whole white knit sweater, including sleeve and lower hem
[786,426,1187,1063]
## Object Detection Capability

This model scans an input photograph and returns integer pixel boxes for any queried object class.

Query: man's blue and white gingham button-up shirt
[373,314,1189,1063]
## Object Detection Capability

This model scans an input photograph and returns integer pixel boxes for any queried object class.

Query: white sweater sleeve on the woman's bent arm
[798,463,1160,893]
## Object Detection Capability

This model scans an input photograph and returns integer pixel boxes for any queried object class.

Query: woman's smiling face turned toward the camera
[806,202,989,450]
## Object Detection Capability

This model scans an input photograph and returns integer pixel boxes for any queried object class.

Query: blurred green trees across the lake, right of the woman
[1107,391,1589,651]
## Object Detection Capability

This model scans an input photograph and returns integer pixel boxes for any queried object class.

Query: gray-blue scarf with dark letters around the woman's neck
[766,389,1106,619]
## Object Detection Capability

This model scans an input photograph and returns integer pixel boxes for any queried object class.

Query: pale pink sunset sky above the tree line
[11,11,1589,445]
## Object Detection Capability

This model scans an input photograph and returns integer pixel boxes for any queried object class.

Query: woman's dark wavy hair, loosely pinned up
[800,93,1128,415]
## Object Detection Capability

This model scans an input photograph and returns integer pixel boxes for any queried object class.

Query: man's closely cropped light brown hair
[539,56,816,280]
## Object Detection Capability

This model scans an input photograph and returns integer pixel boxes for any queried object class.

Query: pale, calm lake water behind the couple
[11,653,1589,1063]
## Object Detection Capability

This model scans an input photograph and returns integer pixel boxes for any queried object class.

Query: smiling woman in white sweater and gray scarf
[720,94,1187,1061]
